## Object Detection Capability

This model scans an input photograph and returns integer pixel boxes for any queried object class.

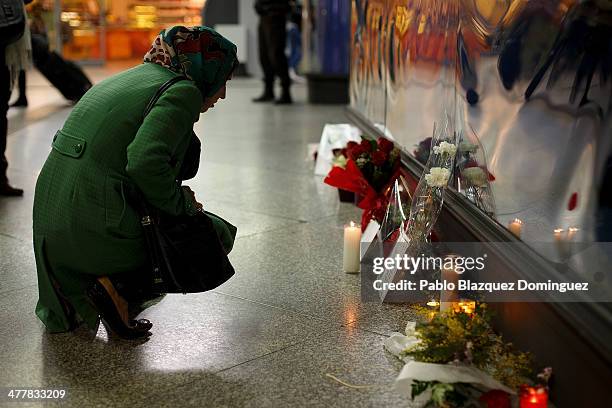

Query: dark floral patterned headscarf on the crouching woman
[144,26,238,97]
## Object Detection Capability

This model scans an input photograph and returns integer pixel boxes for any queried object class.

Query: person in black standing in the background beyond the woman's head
[253,0,293,104]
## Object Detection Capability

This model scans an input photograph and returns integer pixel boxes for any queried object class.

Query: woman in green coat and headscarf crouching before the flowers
[33,26,237,337]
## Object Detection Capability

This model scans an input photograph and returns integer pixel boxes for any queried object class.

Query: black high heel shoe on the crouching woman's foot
[87,278,153,339]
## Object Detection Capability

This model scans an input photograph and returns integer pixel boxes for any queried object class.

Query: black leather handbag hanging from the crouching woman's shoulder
[132,77,236,293]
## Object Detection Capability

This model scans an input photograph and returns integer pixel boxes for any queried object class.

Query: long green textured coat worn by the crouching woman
[33,63,235,332]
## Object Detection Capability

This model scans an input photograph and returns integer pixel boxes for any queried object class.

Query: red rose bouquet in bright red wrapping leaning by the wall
[325,137,400,230]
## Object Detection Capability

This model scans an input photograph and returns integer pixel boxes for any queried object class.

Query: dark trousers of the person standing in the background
[259,15,291,92]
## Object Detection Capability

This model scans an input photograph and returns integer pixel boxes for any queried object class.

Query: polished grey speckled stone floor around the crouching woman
[0,68,418,407]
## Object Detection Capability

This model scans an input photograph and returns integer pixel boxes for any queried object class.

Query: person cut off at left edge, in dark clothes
[0,0,32,196]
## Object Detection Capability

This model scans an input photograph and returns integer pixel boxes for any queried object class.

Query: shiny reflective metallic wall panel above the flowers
[351,0,612,302]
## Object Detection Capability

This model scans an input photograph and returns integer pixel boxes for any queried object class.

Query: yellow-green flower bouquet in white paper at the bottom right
[384,303,552,408]
